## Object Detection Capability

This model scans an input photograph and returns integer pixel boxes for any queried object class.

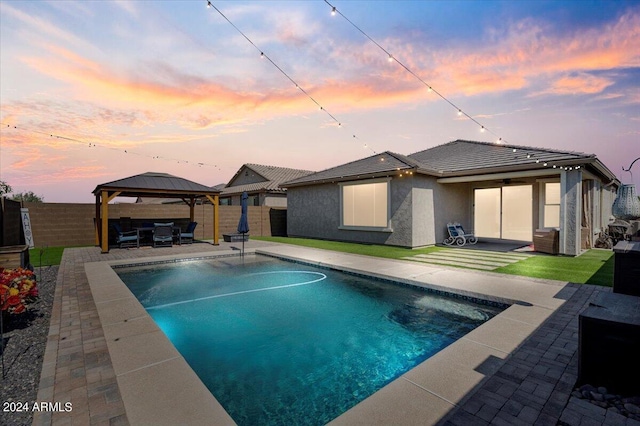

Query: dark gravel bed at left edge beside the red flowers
[0,266,58,426]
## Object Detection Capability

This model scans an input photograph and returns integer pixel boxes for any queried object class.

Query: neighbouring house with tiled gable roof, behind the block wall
[216,164,313,207]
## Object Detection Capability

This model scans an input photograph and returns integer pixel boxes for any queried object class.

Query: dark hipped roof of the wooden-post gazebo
[93,172,220,198]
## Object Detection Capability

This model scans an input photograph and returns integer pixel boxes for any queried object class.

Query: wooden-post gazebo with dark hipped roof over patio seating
[93,172,220,253]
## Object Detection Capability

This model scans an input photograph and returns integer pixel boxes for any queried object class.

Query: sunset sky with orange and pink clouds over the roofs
[0,0,640,203]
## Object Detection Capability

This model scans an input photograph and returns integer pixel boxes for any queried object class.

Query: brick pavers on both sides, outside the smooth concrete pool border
[34,241,640,426]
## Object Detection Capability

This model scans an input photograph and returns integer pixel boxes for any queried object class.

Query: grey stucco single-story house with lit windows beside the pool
[282,140,620,255]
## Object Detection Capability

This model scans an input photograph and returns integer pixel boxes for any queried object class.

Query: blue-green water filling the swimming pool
[117,256,502,425]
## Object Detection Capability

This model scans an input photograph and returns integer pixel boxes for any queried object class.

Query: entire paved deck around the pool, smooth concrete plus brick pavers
[34,241,620,425]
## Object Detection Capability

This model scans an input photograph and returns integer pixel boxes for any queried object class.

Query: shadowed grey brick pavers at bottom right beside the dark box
[440,284,640,426]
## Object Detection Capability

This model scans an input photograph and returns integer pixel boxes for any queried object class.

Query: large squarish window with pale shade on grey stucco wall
[341,180,389,228]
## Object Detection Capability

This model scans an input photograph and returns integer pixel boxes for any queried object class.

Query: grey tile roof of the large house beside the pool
[282,140,613,187]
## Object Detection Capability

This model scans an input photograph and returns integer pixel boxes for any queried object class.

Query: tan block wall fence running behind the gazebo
[24,203,286,247]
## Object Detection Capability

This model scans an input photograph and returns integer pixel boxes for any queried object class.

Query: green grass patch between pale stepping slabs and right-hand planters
[494,250,613,287]
